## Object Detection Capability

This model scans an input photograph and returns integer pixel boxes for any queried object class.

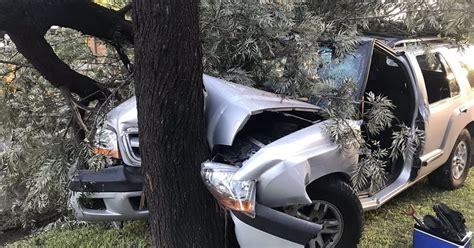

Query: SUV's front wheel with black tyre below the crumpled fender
[286,178,364,248]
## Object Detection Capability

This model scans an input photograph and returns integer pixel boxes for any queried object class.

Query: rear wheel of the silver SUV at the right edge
[428,129,471,190]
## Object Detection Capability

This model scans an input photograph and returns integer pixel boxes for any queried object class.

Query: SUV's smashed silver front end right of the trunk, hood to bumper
[201,77,357,247]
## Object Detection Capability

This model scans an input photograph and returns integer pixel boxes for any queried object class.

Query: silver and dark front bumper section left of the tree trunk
[69,165,148,221]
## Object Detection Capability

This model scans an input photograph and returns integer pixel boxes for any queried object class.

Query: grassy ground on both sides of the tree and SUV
[8,171,474,248]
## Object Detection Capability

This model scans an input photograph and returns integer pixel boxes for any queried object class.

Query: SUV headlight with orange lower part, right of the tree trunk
[201,162,256,217]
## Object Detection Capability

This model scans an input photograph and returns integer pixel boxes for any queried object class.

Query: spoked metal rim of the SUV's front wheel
[286,200,344,248]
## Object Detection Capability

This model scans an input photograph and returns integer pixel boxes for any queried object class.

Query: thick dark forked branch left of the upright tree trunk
[0,0,134,101]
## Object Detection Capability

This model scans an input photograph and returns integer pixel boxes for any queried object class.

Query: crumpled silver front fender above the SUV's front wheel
[234,121,358,207]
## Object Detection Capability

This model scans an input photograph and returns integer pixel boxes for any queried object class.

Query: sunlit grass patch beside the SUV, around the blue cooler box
[359,172,474,248]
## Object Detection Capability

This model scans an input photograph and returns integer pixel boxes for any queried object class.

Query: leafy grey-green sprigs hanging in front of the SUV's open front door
[323,84,424,193]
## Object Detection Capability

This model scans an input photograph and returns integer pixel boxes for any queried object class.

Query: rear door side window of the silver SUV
[416,53,459,104]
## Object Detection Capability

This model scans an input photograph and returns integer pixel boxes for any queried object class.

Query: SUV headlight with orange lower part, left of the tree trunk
[94,128,120,159]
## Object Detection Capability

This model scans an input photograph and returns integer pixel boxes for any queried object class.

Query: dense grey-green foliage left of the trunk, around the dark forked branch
[0,28,133,230]
